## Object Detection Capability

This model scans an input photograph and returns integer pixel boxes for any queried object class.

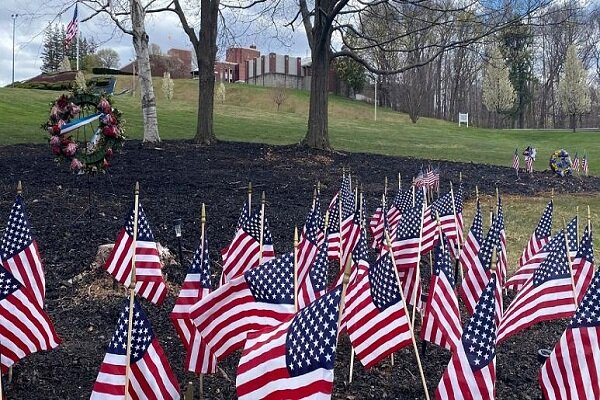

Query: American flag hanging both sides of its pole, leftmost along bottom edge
[90,299,179,400]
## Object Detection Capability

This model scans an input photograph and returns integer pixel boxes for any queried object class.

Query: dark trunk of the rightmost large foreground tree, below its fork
[302,40,331,150]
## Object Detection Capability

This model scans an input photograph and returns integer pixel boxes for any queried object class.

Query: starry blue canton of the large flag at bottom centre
[285,286,342,377]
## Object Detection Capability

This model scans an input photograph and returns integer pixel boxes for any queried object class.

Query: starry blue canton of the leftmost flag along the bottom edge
[107,299,154,363]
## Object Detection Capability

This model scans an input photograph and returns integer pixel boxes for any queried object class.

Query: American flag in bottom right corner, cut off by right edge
[539,271,600,400]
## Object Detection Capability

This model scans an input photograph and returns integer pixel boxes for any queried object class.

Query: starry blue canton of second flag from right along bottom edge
[461,274,496,371]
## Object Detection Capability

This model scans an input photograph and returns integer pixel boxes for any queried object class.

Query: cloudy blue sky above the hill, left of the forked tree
[0,0,308,87]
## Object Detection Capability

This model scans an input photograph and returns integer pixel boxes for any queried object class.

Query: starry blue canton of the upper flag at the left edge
[0,195,33,260]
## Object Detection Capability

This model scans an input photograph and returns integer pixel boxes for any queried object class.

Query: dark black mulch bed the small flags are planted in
[0,141,600,400]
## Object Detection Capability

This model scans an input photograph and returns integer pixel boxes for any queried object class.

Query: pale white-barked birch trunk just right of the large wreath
[131,0,160,143]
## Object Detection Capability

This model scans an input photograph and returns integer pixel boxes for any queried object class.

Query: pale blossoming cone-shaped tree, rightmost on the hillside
[558,45,592,132]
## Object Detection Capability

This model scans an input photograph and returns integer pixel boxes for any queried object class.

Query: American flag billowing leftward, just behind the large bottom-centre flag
[190,253,295,361]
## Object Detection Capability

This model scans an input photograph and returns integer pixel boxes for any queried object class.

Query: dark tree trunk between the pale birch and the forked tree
[194,0,219,145]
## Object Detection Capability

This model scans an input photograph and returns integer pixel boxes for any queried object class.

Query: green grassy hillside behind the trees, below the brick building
[0,78,600,174]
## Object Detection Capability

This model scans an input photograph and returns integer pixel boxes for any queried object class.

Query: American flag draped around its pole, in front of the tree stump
[104,204,167,304]
